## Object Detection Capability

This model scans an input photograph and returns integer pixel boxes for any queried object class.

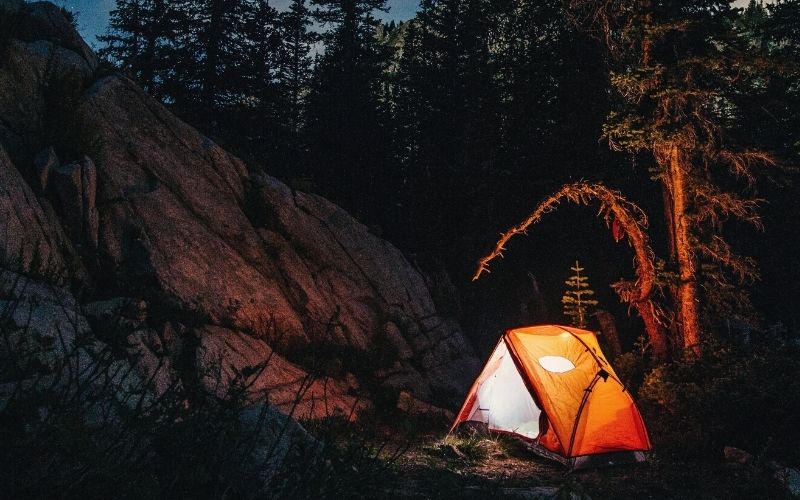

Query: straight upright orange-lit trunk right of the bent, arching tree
[664,144,700,355]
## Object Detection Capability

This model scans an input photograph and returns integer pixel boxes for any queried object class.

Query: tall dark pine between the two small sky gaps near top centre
[306,0,391,218]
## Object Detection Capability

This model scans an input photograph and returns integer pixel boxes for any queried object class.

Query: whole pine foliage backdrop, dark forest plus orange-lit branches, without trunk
[95,0,800,344]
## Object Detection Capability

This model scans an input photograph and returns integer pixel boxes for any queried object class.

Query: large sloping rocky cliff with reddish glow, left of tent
[0,0,478,417]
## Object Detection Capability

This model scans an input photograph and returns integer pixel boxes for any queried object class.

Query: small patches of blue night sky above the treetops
[51,0,419,45]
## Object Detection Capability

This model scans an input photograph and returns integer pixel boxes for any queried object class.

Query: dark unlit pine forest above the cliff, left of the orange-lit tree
[101,0,605,282]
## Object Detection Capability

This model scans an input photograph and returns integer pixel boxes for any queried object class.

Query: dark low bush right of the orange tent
[628,340,800,466]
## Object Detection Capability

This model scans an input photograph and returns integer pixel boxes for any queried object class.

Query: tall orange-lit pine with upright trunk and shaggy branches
[572,0,772,354]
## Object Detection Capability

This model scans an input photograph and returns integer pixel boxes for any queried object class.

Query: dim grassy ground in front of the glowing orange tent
[328,424,791,500]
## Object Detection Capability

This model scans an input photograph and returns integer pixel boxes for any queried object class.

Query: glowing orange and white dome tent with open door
[451,325,651,468]
